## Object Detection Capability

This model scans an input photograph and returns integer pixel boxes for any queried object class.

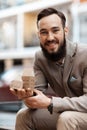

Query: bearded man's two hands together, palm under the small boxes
[10,88,51,108]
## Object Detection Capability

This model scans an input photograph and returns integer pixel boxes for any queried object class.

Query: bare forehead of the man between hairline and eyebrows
[38,14,62,29]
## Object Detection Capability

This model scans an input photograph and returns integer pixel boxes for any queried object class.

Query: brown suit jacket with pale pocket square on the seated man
[34,40,87,112]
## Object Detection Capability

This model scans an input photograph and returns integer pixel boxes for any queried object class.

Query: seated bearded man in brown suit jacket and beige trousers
[11,8,87,130]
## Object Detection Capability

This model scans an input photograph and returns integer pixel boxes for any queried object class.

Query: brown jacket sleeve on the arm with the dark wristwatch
[52,68,87,113]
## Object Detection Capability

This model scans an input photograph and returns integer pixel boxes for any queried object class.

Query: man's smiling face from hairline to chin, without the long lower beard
[38,14,65,60]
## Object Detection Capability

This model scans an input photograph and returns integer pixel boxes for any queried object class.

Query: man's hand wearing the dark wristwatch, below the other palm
[24,89,51,108]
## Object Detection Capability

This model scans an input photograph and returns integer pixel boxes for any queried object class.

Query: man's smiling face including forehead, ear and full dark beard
[38,11,67,61]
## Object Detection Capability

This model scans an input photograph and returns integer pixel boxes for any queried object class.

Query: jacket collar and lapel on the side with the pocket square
[63,41,76,97]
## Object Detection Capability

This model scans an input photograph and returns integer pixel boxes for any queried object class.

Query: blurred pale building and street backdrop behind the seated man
[0,0,87,130]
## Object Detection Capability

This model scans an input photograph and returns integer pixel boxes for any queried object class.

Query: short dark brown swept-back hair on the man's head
[37,8,66,28]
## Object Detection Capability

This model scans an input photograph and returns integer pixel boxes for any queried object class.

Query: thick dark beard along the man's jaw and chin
[40,34,66,62]
